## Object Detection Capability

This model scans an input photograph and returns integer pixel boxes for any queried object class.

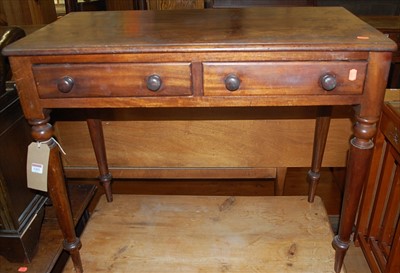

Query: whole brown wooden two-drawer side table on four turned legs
[3,7,396,272]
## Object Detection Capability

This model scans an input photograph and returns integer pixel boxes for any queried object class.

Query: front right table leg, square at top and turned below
[332,52,391,273]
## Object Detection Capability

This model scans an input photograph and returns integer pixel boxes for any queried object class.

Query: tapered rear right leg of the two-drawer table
[307,106,332,202]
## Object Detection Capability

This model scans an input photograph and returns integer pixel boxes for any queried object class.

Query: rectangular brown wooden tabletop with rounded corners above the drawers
[4,7,396,55]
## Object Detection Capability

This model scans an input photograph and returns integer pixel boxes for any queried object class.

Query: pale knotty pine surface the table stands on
[64,195,345,273]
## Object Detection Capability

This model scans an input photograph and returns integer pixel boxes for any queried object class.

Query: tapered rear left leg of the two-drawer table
[87,119,113,202]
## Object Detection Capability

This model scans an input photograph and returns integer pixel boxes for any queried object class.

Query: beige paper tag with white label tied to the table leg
[26,142,50,191]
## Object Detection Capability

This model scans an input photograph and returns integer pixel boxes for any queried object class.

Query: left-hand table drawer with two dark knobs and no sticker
[32,63,192,99]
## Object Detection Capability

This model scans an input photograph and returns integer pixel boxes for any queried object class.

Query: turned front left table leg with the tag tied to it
[29,116,83,273]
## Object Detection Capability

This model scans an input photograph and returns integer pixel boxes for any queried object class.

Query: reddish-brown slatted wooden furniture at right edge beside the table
[356,101,400,273]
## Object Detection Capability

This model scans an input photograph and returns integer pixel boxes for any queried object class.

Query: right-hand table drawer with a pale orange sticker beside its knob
[204,62,367,96]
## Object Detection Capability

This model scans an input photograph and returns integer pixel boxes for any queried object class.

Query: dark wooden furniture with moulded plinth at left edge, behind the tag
[0,27,47,262]
